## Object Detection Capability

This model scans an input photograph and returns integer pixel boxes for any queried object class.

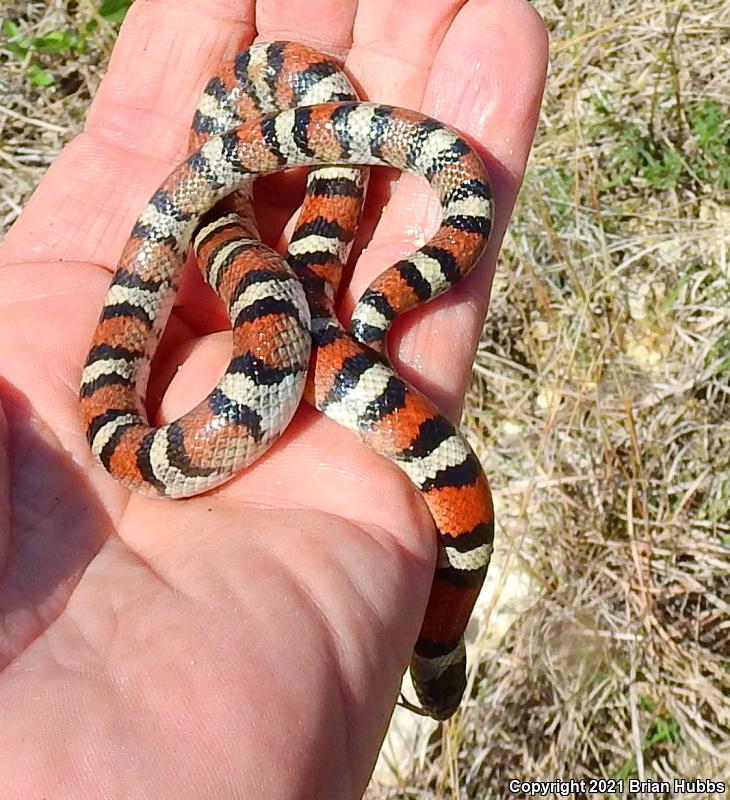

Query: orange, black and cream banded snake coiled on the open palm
[80,41,494,720]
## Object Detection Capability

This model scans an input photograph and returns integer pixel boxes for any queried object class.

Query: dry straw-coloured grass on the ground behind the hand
[0,0,730,800]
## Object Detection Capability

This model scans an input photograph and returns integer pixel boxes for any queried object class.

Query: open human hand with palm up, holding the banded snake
[0,0,547,800]
